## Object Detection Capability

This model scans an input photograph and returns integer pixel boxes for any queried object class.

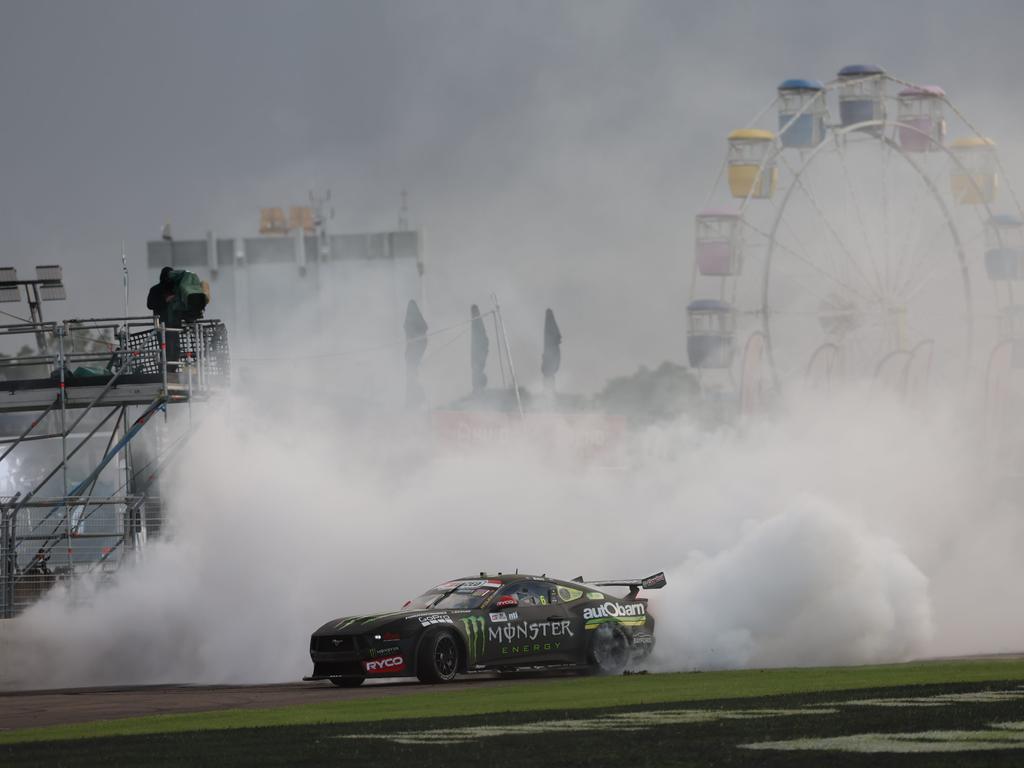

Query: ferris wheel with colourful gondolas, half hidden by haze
[687,65,1024,408]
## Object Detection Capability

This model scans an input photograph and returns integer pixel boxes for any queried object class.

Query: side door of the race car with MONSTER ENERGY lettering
[487,579,579,666]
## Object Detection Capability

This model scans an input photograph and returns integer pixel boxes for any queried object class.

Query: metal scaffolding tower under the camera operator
[0,316,230,617]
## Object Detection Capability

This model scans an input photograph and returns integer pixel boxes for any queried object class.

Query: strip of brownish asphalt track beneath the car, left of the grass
[0,675,528,731]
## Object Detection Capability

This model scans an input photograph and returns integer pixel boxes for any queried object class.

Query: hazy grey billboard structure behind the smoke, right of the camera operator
[146,227,423,404]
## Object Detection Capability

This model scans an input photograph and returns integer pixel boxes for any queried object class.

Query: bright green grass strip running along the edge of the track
[0,659,1024,744]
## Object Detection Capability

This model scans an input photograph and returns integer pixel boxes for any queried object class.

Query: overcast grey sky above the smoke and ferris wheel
[0,0,1024,389]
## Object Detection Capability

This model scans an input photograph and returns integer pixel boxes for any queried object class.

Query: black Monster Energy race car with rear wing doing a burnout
[306,573,666,687]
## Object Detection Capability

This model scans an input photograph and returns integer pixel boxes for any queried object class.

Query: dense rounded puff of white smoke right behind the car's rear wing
[657,498,932,669]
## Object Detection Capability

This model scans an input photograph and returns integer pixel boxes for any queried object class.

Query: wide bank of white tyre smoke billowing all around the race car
[4,378,1024,687]
